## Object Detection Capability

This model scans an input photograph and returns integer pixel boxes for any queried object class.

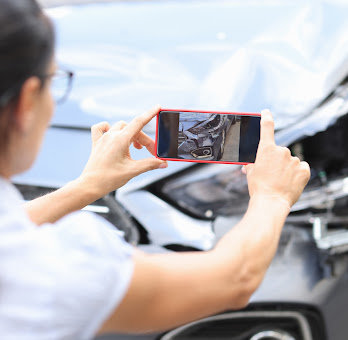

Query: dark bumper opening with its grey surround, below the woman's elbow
[161,311,317,340]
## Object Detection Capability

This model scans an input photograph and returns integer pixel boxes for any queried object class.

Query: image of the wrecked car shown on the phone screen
[178,112,236,161]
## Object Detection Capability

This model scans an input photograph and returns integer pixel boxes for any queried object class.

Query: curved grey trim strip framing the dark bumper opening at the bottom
[160,311,313,340]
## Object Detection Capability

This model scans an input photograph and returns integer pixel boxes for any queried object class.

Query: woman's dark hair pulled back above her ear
[0,0,54,151]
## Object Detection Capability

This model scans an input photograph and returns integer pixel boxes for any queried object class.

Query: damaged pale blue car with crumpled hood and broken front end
[15,0,348,340]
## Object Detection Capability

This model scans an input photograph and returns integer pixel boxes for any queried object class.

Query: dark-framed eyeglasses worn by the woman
[0,69,74,108]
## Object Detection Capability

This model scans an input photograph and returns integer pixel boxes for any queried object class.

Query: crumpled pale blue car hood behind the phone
[46,0,348,128]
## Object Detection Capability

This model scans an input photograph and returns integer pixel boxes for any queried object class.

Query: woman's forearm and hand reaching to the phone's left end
[25,108,167,225]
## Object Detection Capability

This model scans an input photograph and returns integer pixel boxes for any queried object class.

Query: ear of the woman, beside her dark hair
[14,77,41,133]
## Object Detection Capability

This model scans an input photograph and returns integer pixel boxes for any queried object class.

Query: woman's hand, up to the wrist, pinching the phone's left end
[80,107,167,197]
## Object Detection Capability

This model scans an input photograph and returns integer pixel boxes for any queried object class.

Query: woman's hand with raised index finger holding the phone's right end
[245,110,310,207]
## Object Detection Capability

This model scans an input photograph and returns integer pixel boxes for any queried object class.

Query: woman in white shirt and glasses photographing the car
[0,0,309,339]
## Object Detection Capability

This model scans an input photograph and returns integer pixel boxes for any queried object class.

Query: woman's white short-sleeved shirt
[0,212,133,339]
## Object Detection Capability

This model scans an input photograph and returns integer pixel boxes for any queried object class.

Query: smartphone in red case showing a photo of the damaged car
[156,109,261,164]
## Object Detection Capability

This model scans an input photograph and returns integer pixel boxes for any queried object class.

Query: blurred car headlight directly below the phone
[158,164,249,219]
